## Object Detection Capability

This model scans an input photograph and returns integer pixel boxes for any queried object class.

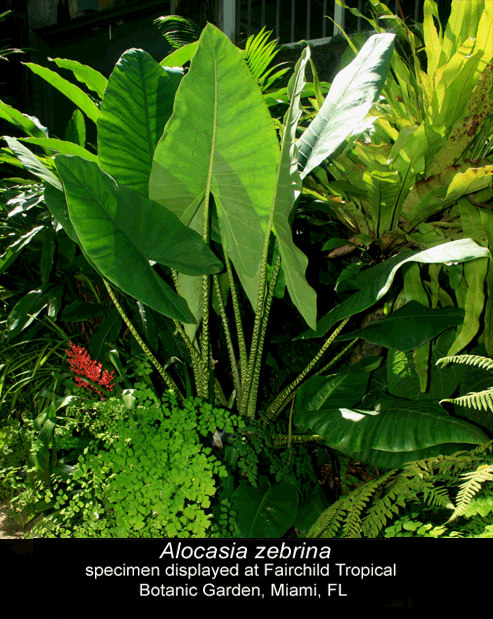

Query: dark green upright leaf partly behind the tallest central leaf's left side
[98,49,183,198]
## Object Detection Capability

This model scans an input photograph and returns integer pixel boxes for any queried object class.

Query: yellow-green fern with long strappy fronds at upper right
[296,0,493,360]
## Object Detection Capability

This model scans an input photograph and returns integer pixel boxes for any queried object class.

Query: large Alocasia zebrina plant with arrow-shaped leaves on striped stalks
[1,25,489,474]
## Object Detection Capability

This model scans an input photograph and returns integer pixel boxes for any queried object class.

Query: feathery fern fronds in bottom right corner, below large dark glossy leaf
[307,441,493,538]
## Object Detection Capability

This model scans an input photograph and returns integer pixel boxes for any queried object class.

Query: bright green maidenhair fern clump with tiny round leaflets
[25,383,242,538]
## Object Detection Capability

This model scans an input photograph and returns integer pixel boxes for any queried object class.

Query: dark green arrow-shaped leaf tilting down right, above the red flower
[55,155,222,322]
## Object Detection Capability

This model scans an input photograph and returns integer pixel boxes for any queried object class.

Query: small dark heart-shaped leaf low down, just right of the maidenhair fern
[231,481,299,539]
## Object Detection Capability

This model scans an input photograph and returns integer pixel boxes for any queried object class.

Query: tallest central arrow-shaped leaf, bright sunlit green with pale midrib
[149,24,279,307]
